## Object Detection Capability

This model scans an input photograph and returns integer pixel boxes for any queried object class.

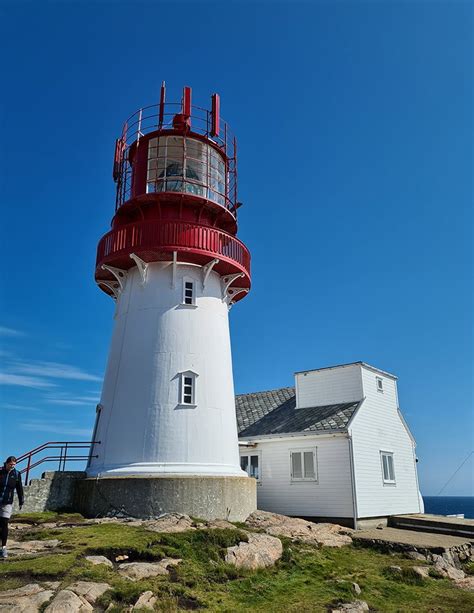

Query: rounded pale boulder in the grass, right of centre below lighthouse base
[225,533,283,570]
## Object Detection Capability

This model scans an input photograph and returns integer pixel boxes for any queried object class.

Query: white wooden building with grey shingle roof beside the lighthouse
[236,362,423,525]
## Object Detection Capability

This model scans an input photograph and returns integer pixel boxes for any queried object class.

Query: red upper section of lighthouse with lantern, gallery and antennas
[95,83,250,304]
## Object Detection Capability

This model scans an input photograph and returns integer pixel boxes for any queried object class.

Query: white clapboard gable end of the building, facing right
[350,366,421,518]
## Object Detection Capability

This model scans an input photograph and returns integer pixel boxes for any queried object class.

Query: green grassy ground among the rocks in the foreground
[0,514,474,613]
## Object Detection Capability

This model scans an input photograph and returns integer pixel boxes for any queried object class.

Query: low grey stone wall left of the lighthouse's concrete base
[13,471,86,513]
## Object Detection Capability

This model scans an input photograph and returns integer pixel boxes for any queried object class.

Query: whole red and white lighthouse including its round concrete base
[80,84,256,520]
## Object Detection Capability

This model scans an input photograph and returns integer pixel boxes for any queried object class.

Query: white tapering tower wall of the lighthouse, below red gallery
[88,263,245,476]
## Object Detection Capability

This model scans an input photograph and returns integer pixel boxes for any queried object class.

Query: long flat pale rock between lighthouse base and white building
[245,511,353,547]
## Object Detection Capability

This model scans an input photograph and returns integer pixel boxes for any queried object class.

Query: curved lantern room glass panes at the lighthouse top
[146,136,226,206]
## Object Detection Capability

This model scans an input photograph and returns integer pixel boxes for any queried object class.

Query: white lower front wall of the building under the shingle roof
[240,436,353,518]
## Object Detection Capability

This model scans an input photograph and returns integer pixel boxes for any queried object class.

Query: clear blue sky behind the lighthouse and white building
[0,1,474,495]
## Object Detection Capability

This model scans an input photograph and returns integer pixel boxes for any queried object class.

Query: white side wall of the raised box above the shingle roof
[295,364,364,409]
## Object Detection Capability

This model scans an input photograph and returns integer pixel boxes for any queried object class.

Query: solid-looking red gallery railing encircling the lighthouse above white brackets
[97,220,250,278]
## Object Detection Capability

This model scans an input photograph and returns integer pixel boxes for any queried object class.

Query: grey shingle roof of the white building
[235,387,360,437]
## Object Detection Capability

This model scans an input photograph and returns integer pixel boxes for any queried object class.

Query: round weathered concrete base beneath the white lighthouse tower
[75,475,257,521]
